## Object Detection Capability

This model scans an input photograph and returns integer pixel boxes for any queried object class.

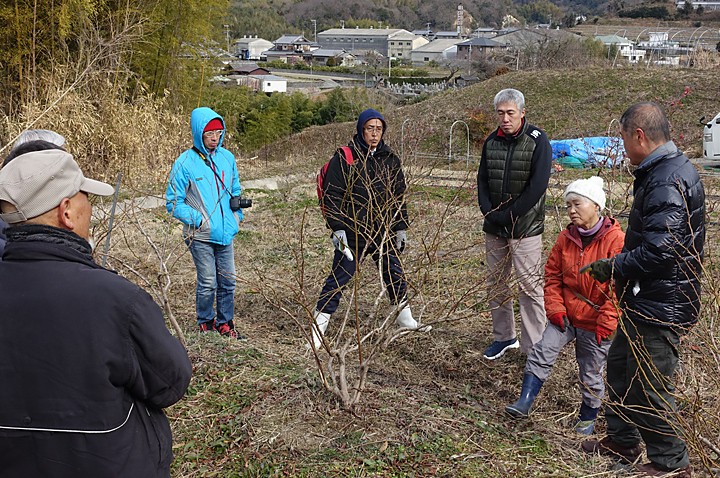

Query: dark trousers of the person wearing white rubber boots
[316,243,407,314]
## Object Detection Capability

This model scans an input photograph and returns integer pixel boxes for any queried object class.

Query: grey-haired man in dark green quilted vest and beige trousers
[477,89,552,360]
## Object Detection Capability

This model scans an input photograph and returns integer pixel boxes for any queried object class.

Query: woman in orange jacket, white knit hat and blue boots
[505,176,625,435]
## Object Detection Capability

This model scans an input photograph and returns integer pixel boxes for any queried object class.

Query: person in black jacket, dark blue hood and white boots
[312,109,430,349]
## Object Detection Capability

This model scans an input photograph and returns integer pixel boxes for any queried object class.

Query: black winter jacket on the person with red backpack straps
[323,136,408,249]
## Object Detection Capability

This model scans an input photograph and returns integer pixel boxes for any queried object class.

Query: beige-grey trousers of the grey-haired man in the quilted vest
[485,234,546,354]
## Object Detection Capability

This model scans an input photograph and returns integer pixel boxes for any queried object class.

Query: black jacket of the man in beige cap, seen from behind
[0,226,192,478]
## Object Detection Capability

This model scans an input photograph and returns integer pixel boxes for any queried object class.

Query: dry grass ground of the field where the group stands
[100,156,720,477]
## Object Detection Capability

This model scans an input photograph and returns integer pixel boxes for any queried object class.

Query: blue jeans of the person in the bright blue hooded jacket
[185,239,235,326]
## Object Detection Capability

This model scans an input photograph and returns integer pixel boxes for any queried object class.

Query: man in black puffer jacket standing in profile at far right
[583,103,705,477]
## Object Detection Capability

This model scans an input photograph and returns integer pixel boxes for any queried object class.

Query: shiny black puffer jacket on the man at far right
[614,142,705,328]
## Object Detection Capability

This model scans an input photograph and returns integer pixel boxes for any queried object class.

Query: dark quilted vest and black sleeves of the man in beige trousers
[477,120,552,239]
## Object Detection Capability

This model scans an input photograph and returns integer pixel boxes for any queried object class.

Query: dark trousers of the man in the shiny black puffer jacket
[605,319,689,470]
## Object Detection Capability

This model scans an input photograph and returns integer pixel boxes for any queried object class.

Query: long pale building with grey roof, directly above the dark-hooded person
[317,28,427,58]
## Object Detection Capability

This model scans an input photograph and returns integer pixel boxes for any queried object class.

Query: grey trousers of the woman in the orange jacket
[525,324,612,408]
